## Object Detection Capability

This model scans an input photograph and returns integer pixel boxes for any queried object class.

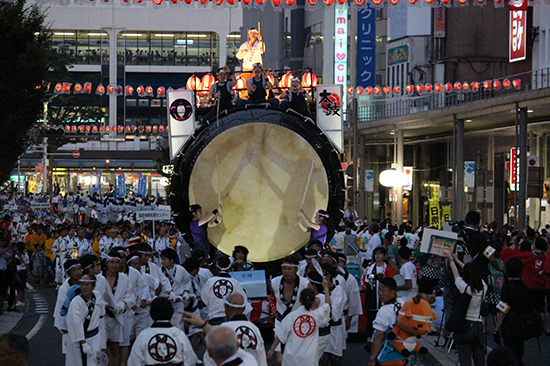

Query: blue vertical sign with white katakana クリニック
[357,4,376,87]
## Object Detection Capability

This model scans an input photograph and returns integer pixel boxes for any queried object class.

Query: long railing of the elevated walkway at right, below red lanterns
[357,68,550,122]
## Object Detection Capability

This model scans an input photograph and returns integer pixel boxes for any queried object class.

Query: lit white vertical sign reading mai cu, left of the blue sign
[334,4,348,110]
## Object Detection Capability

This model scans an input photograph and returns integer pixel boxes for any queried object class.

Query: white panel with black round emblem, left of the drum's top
[166,90,195,160]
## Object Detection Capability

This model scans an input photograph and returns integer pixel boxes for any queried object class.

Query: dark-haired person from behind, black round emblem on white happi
[128,297,197,366]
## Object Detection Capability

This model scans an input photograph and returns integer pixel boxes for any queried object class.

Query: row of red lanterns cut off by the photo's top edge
[38,0,516,7]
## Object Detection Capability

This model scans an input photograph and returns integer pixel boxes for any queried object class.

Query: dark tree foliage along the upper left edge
[0,0,67,182]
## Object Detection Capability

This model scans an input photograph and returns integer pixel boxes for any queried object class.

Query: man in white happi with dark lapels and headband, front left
[67,274,105,366]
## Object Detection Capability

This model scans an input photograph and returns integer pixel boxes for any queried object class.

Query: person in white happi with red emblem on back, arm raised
[267,288,331,366]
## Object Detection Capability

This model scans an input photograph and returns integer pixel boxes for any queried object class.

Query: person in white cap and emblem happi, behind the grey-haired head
[183,293,267,366]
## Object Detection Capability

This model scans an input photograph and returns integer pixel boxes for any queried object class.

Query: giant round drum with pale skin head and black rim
[170,105,345,262]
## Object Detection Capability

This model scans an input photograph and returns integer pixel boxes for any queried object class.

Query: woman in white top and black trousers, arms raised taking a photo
[447,253,487,366]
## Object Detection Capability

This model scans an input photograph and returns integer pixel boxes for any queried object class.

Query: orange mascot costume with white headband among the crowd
[388,294,438,357]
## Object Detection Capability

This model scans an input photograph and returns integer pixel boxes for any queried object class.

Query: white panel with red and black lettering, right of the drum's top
[315,85,344,152]
